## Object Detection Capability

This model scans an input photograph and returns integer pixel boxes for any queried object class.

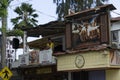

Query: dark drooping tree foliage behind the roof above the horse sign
[53,0,108,20]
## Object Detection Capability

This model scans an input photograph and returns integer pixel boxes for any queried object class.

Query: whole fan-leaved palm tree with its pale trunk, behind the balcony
[11,3,38,53]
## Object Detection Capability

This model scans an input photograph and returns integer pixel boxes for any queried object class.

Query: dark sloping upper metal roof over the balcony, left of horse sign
[23,21,65,37]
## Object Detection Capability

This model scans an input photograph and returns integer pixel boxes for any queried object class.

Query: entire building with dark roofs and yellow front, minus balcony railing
[10,4,120,80]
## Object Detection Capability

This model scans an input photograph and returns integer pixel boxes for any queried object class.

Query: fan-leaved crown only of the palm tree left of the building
[11,3,38,29]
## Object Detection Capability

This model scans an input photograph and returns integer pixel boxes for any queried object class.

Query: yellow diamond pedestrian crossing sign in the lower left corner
[0,67,13,80]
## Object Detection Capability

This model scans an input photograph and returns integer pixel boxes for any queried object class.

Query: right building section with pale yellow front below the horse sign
[56,4,120,80]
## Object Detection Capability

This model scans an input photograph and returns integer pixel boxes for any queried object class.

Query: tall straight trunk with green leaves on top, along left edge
[0,0,13,67]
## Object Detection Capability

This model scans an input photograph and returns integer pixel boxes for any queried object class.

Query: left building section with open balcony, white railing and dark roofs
[12,21,66,80]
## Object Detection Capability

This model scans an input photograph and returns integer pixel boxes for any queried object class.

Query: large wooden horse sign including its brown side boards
[66,12,109,49]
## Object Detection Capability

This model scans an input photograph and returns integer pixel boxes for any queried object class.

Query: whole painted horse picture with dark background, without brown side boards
[72,15,101,48]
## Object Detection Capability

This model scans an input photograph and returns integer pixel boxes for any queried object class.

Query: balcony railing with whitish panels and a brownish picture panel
[12,49,56,68]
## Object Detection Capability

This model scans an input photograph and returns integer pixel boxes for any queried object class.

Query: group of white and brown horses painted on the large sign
[72,16,100,42]
